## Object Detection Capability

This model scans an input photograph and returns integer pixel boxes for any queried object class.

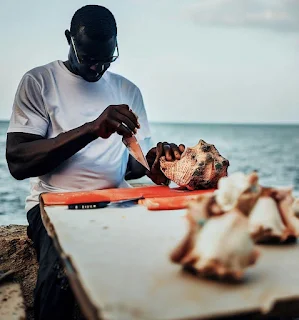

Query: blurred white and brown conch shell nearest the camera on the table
[171,205,259,280]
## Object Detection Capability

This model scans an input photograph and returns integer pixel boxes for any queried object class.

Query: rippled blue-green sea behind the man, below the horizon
[0,121,299,225]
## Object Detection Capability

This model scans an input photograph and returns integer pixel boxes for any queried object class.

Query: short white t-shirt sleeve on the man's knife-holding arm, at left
[7,74,49,137]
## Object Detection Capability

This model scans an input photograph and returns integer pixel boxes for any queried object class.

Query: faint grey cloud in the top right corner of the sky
[187,0,299,32]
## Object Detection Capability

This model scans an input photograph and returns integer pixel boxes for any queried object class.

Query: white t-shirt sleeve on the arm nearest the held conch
[131,87,152,152]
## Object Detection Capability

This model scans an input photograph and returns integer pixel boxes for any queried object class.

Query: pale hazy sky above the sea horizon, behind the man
[0,0,299,124]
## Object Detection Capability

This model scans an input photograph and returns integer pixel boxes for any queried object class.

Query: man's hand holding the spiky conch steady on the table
[146,142,185,185]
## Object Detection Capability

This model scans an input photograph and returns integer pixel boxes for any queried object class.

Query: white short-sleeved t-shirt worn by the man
[8,61,151,211]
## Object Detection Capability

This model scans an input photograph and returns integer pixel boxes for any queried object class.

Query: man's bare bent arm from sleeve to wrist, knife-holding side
[6,124,97,180]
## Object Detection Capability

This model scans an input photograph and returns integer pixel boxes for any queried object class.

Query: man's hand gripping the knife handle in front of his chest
[91,104,140,139]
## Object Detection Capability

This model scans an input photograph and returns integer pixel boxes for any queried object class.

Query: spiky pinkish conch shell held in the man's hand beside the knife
[160,140,229,190]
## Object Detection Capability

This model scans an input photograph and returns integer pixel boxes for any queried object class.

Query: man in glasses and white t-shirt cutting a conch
[6,5,184,320]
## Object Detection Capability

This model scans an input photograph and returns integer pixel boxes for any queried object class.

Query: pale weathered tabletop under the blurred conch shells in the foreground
[41,205,299,320]
